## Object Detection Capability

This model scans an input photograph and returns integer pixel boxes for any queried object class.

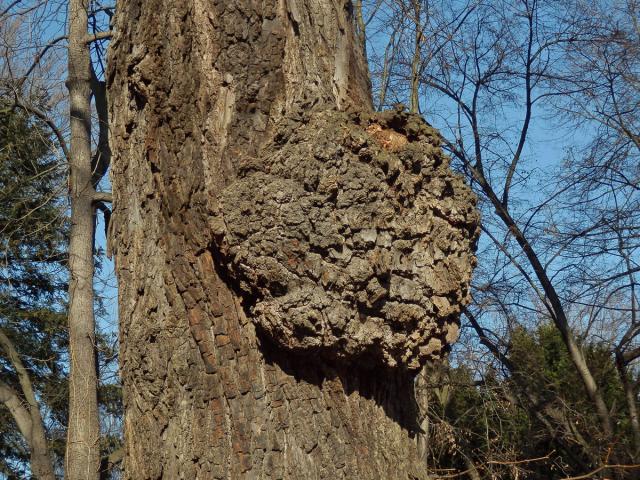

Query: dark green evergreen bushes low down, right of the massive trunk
[422,324,638,480]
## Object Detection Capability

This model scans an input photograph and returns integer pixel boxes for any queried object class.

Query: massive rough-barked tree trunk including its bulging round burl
[108,0,477,479]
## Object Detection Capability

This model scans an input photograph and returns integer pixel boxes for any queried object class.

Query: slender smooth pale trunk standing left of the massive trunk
[65,0,100,480]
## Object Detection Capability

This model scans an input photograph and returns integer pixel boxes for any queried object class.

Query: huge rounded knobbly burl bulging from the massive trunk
[214,110,479,370]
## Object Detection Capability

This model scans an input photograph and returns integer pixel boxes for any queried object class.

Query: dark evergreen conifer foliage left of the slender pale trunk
[0,101,67,469]
